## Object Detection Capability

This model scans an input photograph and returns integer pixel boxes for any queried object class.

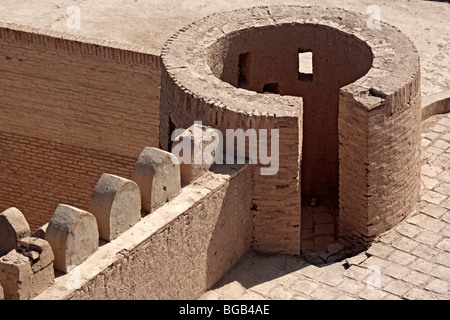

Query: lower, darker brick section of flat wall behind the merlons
[0,132,136,230]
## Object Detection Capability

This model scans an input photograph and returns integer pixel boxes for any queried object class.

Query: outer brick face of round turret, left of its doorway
[160,60,301,254]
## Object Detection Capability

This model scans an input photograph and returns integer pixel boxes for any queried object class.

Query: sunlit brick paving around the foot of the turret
[200,113,450,300]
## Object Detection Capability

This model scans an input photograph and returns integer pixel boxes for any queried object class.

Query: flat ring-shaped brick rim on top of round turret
[161,5,419,117]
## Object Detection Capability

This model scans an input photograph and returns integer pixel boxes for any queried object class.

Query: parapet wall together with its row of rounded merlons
[0,134,253,299]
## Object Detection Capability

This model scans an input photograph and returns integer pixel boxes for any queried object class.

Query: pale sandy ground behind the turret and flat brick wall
[0,0,450,95]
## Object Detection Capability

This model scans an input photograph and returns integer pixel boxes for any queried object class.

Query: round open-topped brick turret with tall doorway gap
[160,6,421,254]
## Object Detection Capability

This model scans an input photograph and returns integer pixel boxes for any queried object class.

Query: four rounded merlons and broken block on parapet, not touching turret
[0,132,213,300]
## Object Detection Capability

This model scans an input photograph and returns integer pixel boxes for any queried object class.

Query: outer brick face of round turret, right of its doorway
[339,59,422,244]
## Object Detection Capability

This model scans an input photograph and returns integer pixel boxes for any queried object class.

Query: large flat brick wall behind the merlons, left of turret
[0,24,160,230]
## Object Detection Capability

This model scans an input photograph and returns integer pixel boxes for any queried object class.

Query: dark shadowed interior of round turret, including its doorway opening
[209,23,373,252]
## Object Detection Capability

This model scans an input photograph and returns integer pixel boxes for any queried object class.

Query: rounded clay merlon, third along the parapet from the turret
[88,173,141,241]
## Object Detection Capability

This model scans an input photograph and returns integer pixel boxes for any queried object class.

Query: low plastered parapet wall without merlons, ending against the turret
[35,165,252,300]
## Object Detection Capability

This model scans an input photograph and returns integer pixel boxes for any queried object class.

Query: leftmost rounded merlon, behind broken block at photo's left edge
[0,207,30,255]
